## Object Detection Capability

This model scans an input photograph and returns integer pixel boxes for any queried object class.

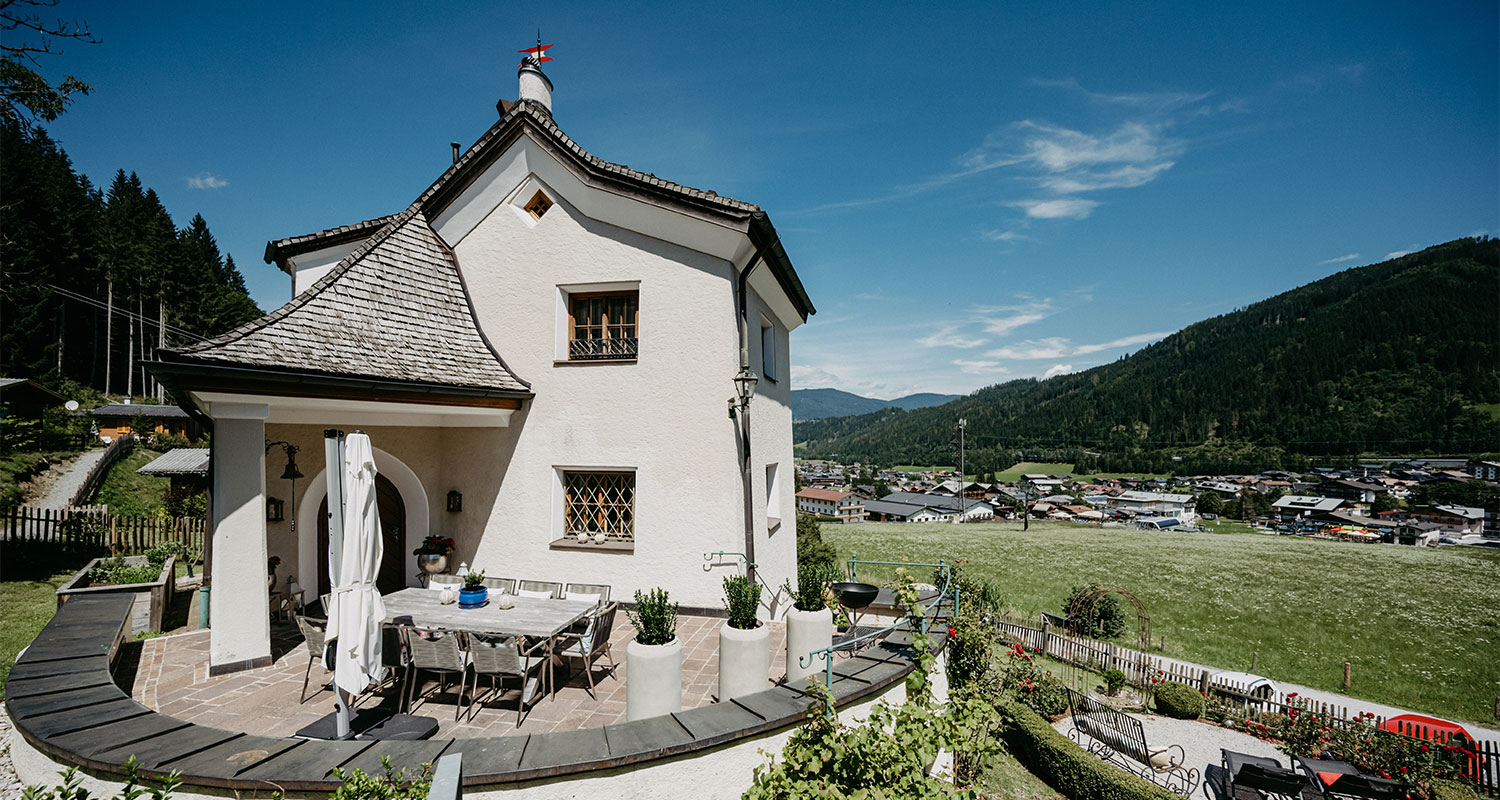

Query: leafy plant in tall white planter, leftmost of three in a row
[626,588,683,722]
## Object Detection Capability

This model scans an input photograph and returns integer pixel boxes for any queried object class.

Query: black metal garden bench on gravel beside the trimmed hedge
[1068,689,1199,797]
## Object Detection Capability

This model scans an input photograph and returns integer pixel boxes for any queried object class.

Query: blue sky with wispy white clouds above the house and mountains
[35,0,1500,398]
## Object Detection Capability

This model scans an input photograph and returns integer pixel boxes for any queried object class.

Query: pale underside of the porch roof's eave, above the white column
[189,392,521,428]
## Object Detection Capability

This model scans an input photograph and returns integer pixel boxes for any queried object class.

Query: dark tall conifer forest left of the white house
[0,114,261,398]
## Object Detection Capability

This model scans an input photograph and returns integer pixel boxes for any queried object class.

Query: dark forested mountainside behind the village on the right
[794,237,1500,471]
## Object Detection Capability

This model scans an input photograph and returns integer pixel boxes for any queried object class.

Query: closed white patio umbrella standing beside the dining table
[324,431,386,738]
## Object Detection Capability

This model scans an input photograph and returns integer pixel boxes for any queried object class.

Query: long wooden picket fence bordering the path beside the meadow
[995,611,1500,795]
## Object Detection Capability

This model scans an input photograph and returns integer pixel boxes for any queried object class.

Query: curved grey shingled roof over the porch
[164,204,530,393]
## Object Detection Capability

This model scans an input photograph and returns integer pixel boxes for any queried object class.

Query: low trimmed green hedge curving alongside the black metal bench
[1001,702,1182,800]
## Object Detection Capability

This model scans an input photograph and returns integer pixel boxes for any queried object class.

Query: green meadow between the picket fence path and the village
[822,522,1500,725]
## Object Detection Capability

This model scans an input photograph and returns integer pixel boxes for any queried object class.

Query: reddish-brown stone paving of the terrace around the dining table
[132,611,786,738]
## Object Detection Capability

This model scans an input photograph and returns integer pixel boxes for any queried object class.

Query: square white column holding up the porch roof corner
[209,404,272,674]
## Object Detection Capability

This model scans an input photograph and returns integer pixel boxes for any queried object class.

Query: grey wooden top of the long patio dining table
[381,588,596,638]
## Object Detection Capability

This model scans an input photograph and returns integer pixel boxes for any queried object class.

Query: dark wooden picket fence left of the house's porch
[0,506,206,555]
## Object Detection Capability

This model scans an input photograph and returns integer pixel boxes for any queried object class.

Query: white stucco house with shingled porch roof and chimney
[152,60,815,672]
